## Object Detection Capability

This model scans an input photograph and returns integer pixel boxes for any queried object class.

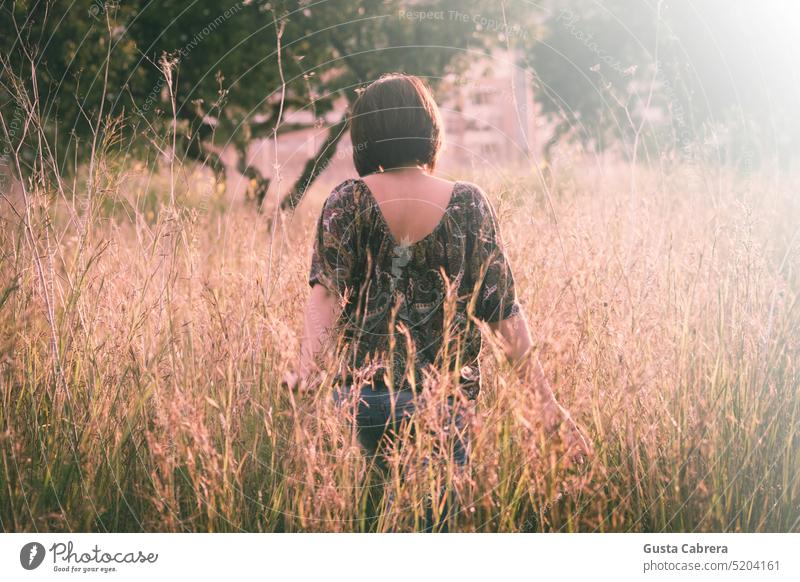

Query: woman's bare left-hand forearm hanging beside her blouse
[286,284,339,388]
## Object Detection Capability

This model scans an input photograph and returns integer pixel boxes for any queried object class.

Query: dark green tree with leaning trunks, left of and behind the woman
[0,0,500,207]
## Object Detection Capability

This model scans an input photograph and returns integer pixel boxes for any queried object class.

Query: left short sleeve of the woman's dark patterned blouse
[308,181,358,297]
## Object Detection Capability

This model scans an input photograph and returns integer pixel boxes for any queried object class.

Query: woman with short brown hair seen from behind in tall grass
[290,74,590,528]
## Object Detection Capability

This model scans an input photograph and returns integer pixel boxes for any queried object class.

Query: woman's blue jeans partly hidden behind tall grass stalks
[334,384,469,532]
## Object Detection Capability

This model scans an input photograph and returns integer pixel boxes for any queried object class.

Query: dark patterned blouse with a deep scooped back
[309,179,519,398]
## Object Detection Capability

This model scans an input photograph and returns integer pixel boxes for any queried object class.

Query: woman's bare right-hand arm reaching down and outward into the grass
[489,308,592,458]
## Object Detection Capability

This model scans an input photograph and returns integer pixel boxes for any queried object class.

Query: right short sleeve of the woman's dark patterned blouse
[472,186,520,323]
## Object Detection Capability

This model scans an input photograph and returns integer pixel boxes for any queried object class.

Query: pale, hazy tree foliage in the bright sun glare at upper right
[525,0,800,164]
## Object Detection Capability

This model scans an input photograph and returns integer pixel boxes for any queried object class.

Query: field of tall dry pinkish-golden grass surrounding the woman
[0,156,800,531]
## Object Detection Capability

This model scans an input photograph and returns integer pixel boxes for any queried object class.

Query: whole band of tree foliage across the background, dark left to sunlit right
[0,0,800,182]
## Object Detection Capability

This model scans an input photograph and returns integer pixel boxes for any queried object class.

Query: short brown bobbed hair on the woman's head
[350,73,444,176]
